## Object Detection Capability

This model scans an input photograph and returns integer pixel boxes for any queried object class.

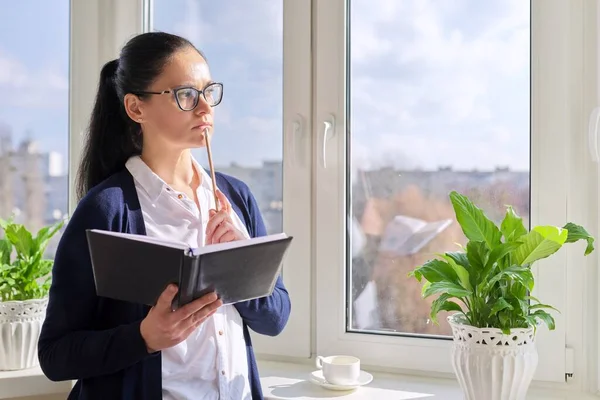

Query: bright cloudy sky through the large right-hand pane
[351,0,529,169]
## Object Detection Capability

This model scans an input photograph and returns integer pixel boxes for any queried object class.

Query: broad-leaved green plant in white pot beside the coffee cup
[409,192,594,400]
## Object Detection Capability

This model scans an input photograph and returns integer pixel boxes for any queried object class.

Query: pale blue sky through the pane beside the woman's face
[157,0,283,166]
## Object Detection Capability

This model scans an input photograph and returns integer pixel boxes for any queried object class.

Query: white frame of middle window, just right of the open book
[244,0,313,359]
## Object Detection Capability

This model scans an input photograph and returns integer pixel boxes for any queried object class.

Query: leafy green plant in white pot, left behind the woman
[0,220,64,370]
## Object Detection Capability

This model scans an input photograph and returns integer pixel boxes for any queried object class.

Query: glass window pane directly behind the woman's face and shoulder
[153,0,283,233]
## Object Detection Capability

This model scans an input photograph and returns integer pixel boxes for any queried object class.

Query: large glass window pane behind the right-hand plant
[347,0,530,335]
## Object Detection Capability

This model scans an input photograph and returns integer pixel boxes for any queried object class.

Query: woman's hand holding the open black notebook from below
[140,285,223,353]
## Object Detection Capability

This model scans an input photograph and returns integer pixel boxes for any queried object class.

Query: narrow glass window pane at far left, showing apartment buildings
[0,0,69,258]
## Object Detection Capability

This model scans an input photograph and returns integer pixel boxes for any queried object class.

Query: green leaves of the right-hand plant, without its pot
[409,192,594,333]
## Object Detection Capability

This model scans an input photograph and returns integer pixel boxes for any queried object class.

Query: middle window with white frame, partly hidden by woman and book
[151,0,311,356]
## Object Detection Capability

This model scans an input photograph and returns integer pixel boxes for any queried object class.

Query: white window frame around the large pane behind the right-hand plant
[313,0,585,382]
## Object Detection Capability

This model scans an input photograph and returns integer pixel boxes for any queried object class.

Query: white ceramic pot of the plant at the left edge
[0,298,48,371]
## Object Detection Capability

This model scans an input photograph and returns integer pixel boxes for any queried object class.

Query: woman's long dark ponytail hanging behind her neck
[77,59,142,200]
